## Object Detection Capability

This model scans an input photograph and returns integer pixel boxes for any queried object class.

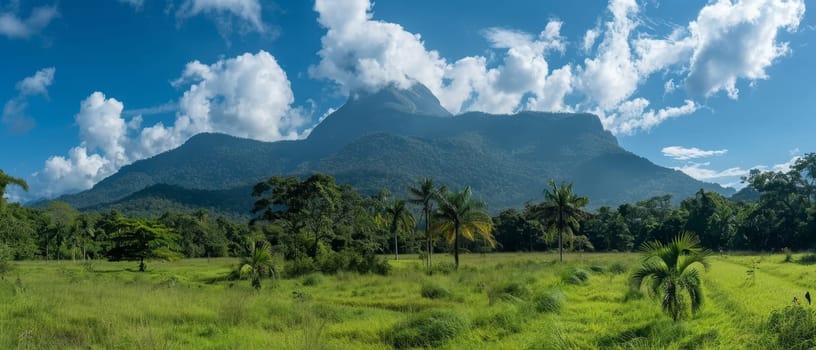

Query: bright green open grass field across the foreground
[0,254,816,349]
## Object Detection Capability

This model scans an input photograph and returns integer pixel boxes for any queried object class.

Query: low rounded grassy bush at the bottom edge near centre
[383,310,468,349]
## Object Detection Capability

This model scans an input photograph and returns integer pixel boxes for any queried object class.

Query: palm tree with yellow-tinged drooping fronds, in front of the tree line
[433,187,495,270]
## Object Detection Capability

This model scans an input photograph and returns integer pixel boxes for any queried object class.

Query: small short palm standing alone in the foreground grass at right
[629,232,710,321]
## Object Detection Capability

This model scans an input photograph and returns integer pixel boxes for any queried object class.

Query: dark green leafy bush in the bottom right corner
[766,305,816,349]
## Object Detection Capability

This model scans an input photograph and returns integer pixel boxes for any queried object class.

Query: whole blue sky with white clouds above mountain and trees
[0,0,816,200]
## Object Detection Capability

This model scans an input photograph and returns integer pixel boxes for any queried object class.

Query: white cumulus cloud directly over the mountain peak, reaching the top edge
[310,0,572,113]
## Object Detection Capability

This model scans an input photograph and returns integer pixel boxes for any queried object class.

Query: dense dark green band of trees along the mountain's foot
[0,154,816,272]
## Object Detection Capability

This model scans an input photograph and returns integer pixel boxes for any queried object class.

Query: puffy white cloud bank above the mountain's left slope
[32,51,309,197]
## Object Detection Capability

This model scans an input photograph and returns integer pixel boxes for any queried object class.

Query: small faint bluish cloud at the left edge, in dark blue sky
[0,67,56,134]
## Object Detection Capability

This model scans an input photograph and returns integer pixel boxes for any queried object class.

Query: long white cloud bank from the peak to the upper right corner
[310,0,804,134]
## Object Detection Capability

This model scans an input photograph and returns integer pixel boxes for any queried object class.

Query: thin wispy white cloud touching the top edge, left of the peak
[176,0,266,32]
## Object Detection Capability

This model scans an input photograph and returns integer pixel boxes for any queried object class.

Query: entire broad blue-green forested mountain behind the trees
[54,84,733,216]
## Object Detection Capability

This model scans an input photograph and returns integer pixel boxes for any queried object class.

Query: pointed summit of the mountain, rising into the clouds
[346,82,451,117]
